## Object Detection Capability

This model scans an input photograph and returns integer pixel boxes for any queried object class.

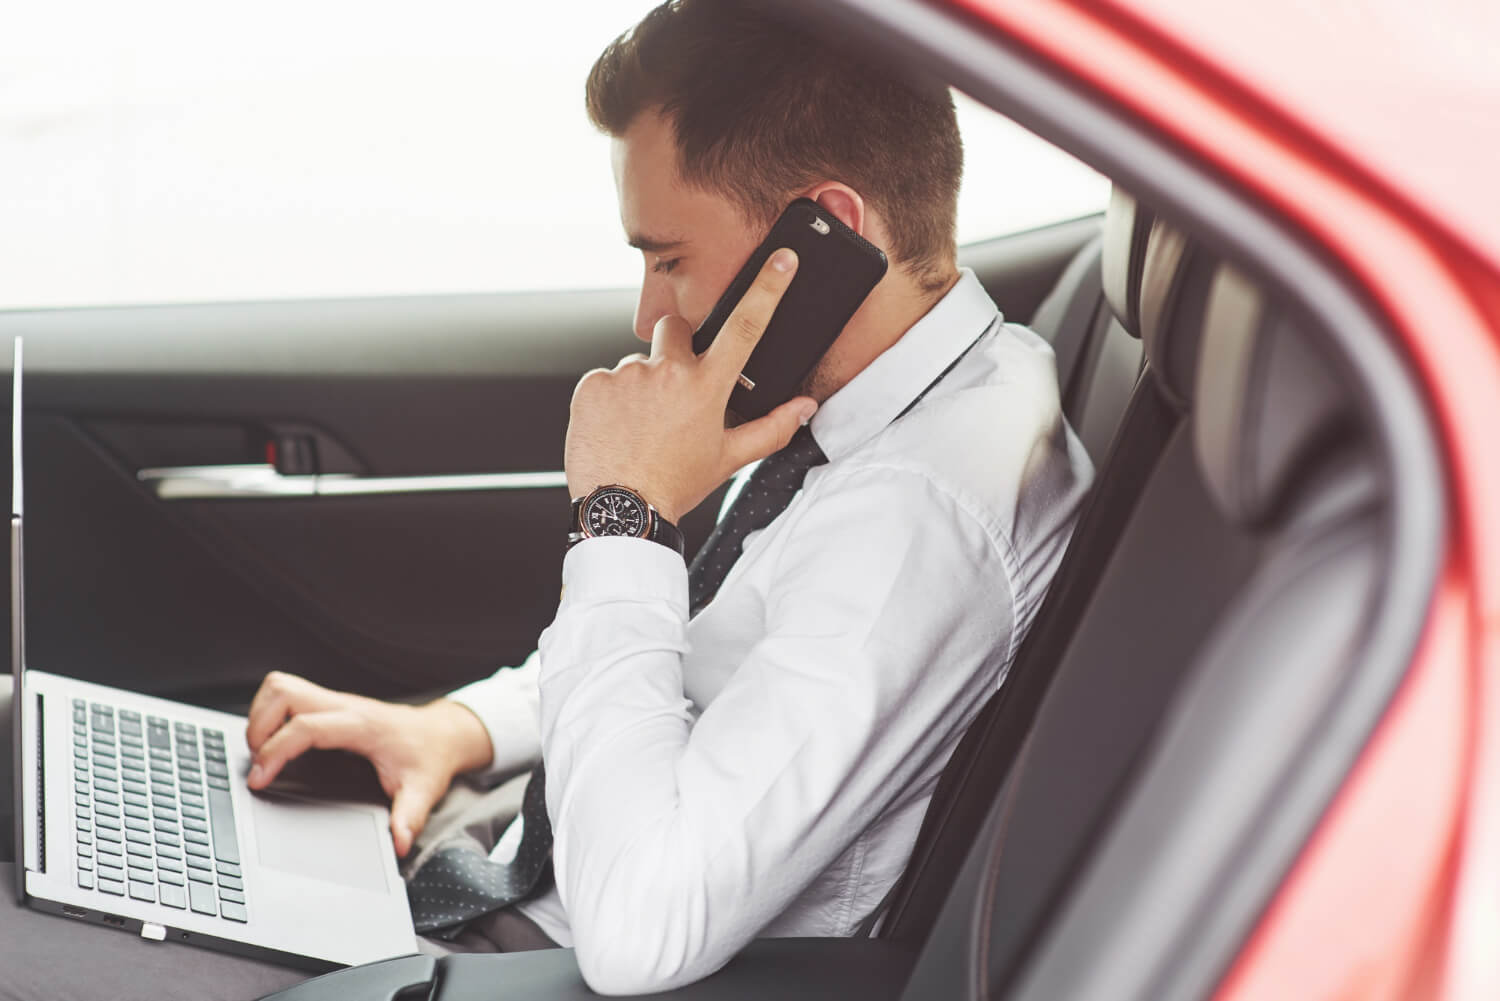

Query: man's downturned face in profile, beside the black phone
[614,111,765,341]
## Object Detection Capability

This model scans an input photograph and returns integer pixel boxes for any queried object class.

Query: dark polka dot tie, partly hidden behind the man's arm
[407,428,828,939]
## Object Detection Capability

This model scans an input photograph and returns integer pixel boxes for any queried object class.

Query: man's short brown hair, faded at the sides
[587,0,963,289]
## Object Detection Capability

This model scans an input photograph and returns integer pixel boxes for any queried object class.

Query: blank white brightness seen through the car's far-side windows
[0,0,1109,308]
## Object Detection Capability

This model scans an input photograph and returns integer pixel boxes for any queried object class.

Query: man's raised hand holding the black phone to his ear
[564,248,818,522]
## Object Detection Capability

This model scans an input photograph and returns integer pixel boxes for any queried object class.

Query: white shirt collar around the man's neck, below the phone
[812,267,1001,461]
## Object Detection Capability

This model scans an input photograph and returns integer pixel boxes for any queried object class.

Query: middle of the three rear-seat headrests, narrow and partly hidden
[1140,219,1217,404]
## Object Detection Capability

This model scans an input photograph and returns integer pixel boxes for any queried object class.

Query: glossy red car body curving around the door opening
[957,0,1500,1001]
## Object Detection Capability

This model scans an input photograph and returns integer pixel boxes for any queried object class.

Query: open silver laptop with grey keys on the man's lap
[11,338,416,968]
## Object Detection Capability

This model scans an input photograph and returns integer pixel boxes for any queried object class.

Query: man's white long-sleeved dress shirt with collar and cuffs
[453,270,1092,993]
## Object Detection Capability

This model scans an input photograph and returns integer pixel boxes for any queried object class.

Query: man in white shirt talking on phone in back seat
[0,0,1091,993]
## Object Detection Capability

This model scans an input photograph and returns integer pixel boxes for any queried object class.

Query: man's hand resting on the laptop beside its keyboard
[246,671,492,855]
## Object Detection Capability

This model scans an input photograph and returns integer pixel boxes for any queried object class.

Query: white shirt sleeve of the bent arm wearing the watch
[540,467,1013,993]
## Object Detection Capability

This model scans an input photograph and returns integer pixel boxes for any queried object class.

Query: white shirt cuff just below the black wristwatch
[563,537,687,618]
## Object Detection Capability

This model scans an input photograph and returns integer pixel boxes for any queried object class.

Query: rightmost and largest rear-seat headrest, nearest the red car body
[1193,267,1356,525]
